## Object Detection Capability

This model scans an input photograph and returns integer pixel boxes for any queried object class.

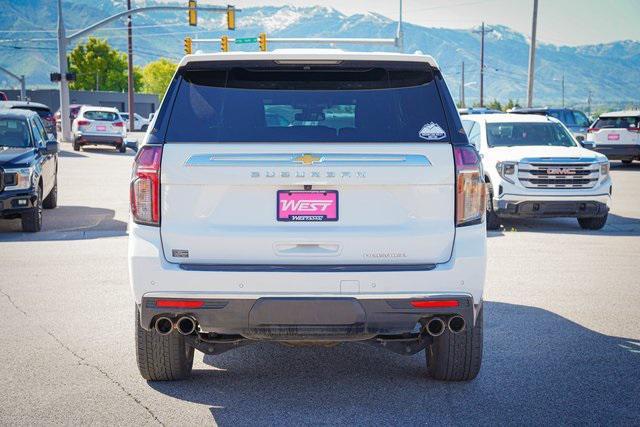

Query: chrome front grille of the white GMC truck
[518,159,600,188]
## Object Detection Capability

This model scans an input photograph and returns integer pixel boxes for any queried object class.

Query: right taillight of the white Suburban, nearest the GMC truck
[453,146,486,227]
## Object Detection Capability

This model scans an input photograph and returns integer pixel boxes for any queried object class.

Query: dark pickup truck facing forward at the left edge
[0,109,58,232]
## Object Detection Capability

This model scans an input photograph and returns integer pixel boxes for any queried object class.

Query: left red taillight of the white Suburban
[130,145,162,226]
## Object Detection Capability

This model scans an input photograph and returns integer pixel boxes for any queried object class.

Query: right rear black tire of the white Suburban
[425,309,483,381]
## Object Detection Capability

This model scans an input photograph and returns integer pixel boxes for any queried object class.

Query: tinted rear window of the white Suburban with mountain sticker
[166,64,448,142]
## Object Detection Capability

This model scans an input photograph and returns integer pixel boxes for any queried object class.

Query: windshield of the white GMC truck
[487,123,576,147]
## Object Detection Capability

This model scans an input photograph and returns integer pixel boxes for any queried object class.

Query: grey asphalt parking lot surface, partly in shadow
[0,140,640,425]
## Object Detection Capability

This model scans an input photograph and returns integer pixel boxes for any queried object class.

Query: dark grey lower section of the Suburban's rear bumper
[140,294,474,341]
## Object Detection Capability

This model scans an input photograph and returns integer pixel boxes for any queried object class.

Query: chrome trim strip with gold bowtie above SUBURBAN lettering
[184,153,432,168]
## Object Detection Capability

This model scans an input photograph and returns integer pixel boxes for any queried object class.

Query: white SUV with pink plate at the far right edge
[587,110,640,164]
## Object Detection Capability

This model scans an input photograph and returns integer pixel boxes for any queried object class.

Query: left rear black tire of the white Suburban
[136,307,194,381]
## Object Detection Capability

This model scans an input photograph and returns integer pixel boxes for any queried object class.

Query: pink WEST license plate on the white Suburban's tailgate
[276,190,338,222]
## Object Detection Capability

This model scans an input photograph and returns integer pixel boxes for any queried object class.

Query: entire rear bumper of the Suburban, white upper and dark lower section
[128,223,486,339]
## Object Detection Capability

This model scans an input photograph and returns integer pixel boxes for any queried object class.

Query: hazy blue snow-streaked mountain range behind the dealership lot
[0,0,640,107]
